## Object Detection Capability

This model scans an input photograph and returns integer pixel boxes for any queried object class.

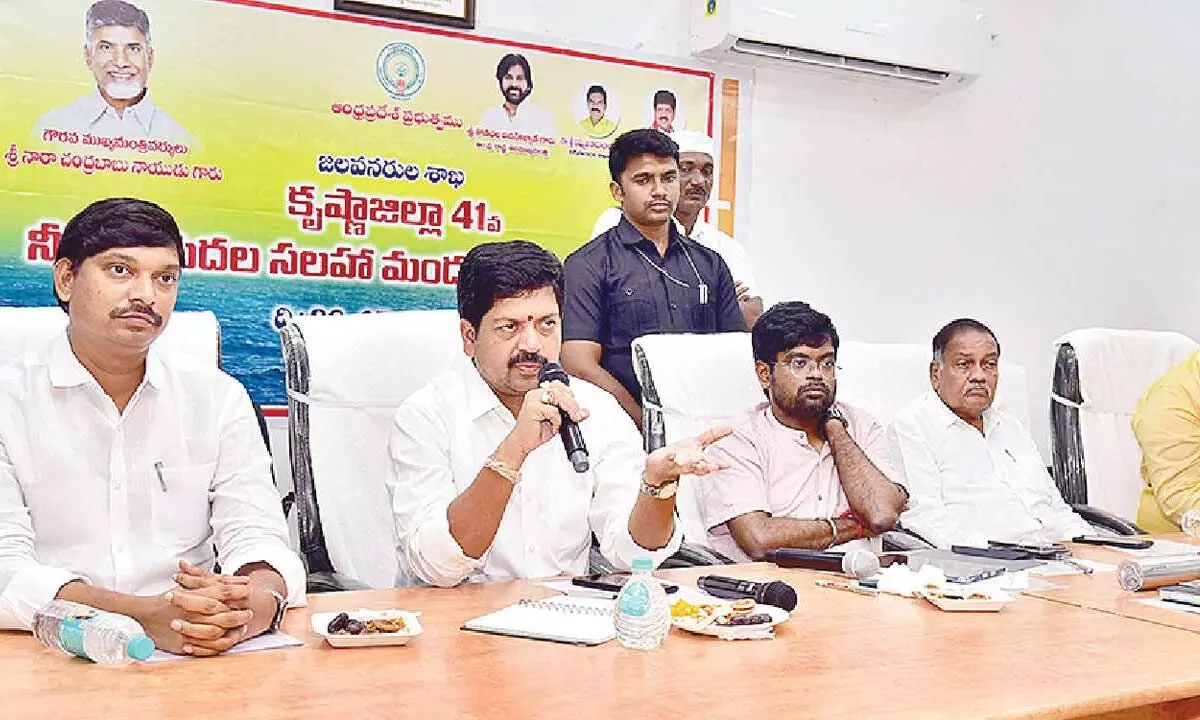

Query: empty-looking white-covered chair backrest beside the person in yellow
[1050,328,1200,520]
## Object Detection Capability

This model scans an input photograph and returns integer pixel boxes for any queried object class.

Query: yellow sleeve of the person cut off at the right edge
[1133,362,1200,523]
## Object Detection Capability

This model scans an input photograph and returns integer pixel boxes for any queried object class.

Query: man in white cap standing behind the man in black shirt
[592,131,763,328]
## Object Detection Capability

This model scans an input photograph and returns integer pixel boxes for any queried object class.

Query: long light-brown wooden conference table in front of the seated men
[11,556,1200,720]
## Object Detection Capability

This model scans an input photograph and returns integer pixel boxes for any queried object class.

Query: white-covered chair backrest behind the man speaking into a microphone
[280,310,462,588]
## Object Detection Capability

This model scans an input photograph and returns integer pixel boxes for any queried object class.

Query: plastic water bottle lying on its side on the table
[34,600,154,665]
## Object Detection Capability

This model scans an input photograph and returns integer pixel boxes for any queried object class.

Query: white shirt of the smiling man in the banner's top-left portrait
[37,90,196,145]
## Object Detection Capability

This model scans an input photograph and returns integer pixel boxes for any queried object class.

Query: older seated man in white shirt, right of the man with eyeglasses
[888,318,1091,547]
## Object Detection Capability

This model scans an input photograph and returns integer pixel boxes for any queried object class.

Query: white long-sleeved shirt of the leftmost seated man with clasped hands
[0,332,305,629]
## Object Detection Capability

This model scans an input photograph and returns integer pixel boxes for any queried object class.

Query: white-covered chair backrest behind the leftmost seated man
[0,305,221,367]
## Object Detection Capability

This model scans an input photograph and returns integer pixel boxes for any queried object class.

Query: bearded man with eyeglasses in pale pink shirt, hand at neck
[697,302,908,562]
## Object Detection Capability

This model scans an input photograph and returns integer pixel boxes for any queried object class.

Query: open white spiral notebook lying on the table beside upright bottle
[462,598,617,646]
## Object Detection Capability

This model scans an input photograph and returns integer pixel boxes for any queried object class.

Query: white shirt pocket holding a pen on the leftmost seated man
[151,462,217,551]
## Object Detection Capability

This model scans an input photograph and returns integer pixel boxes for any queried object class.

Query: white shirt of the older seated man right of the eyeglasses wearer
[888,390,1091,547]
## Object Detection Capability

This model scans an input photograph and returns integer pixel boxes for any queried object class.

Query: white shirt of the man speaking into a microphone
[388,358,682,586]
